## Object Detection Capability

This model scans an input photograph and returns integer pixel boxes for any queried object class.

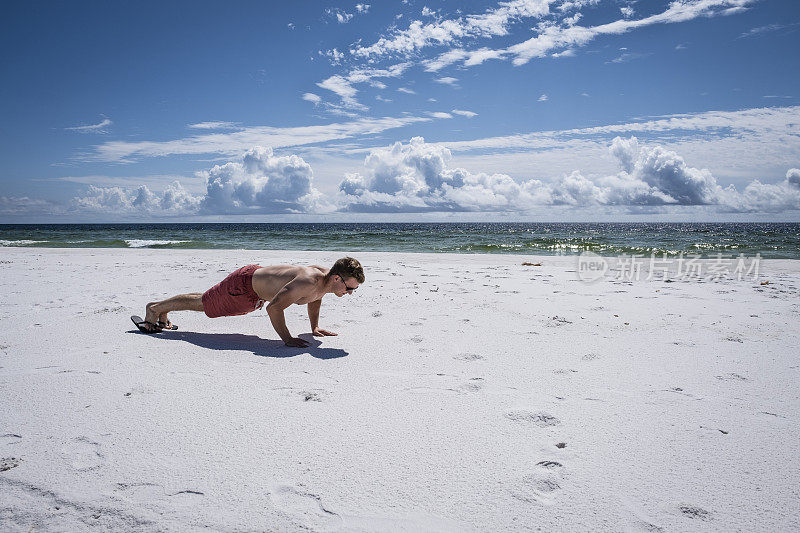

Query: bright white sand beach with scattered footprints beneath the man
[0,248,800,532]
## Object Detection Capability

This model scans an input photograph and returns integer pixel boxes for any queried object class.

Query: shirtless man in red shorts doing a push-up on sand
[131,257,364,348]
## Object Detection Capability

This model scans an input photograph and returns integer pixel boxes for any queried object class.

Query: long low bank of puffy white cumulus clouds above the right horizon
[338,137,800,212]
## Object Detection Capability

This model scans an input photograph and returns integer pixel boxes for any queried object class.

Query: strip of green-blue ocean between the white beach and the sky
[0,223,800,259]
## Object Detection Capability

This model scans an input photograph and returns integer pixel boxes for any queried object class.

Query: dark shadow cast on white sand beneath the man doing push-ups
[129,330,350,359]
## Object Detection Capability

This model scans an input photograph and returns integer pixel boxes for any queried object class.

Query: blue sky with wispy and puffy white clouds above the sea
[0,0,800,222]
